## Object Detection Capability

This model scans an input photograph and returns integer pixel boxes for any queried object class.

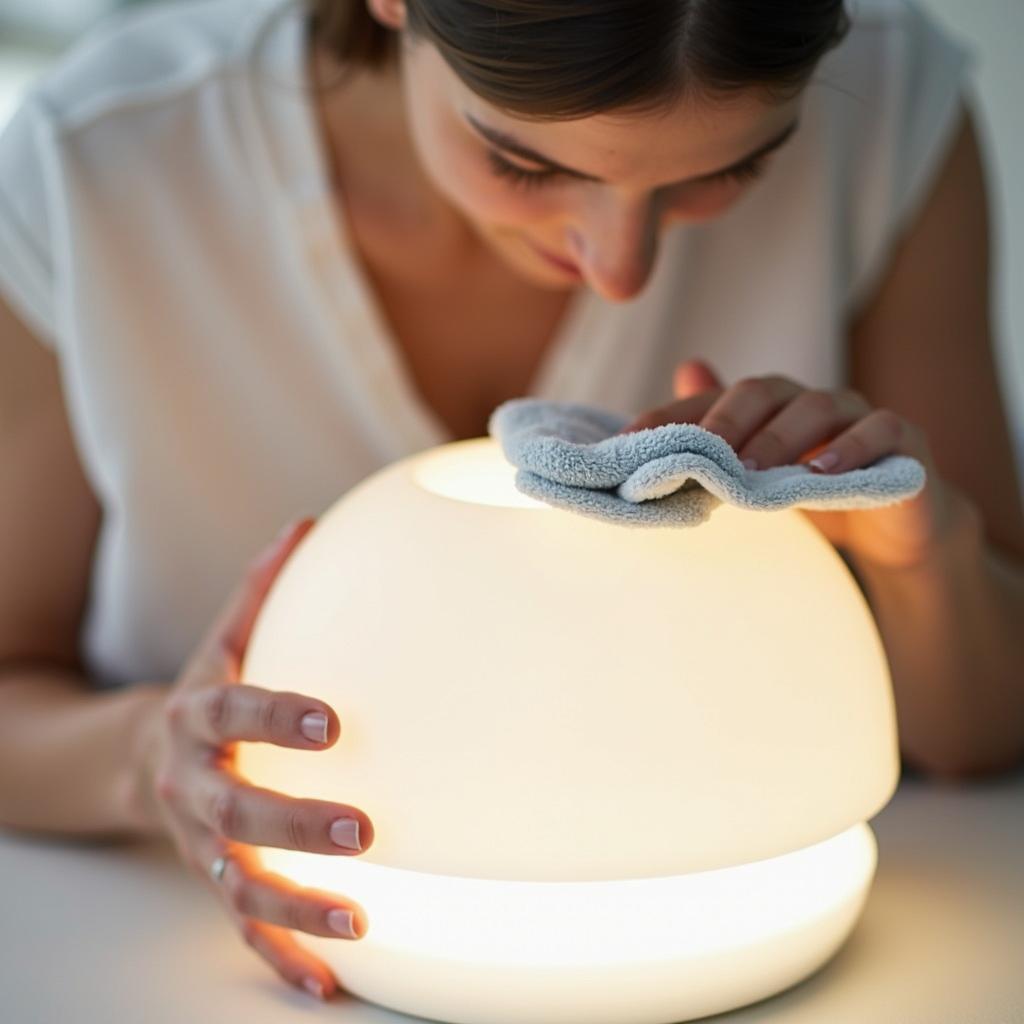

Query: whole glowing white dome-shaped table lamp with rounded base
[239,438,899,1024]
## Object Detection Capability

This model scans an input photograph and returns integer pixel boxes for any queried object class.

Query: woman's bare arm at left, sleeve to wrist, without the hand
[0,292,157,834]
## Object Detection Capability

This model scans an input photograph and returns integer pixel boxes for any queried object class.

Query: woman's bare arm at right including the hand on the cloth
[624,103,1024,777]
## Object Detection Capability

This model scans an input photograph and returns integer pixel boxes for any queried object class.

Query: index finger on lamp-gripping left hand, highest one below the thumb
[174,682,341,750]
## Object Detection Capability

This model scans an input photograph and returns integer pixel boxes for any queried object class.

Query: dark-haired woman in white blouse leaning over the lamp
[0,0,1024,997]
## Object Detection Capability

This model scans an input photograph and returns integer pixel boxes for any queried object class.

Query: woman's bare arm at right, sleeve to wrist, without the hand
[851,105,1024,776]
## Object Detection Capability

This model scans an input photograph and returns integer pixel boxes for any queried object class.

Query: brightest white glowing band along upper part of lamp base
[263,824,876,967]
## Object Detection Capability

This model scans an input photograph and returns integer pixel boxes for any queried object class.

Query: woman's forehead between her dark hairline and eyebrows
[411,39,803,183]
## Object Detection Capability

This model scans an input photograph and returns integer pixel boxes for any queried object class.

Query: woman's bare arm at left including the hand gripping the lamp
[0,290,373,997]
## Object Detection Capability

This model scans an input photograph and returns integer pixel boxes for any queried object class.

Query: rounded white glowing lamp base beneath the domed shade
[263,824,878,1024]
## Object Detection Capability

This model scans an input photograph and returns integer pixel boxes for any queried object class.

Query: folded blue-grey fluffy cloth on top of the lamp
[487,398,925,526]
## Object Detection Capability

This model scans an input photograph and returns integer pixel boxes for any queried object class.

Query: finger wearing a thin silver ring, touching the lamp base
[211,834,367,940]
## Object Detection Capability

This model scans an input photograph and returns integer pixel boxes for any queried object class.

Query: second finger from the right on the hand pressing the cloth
[737,390,871,469]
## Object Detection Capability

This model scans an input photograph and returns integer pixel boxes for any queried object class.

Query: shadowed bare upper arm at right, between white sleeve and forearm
[850,105,1024,559]
